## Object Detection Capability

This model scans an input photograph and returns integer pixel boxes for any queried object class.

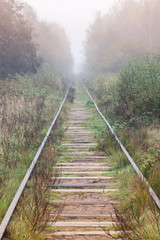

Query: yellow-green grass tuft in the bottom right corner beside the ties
[107,203,160,240]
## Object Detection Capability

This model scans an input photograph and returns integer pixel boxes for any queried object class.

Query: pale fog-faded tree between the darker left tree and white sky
[36,21,73,74]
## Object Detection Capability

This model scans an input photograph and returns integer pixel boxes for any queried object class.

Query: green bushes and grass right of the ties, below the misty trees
[85,55,160,240]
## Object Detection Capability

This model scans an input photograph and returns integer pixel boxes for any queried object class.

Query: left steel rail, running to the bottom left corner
[0,88,70,239]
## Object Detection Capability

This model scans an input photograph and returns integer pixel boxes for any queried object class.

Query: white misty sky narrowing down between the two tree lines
[24,0,117,72]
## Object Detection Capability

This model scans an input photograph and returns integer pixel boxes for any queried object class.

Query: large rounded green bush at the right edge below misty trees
[117,57,160,121]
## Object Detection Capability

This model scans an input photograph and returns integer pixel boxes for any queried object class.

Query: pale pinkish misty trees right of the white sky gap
[85,0,160,72]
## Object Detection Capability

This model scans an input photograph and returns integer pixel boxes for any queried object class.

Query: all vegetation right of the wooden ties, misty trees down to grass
[83,0,160,237]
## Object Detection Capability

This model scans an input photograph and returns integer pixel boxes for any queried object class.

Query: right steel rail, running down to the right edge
[84,86,160,209]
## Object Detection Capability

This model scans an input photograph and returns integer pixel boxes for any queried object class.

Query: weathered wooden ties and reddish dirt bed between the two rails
[47,87,118,240]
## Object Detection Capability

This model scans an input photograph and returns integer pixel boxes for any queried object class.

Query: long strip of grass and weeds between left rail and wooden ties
[4,98,70,240]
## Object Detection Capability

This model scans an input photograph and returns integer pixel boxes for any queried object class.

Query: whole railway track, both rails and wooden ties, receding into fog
[0,87,160,240]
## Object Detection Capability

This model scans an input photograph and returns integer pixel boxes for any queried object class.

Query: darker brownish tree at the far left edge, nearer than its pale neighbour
[0,0,40,77]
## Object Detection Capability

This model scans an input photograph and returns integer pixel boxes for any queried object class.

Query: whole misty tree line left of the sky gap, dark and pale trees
[0,0,73,78]
